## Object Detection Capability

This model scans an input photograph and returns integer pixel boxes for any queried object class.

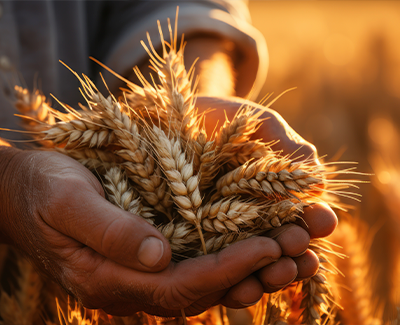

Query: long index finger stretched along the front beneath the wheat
[71,237,281,311]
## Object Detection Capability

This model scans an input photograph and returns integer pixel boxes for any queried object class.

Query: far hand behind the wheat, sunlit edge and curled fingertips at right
[196,96,337,298]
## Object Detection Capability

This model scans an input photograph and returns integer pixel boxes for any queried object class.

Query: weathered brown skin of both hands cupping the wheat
[0,97,337,316]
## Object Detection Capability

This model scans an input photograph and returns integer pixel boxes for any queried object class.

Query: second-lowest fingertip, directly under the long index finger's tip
[257,257,297,293]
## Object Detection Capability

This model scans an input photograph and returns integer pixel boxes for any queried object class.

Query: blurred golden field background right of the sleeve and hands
[249,1,400,318]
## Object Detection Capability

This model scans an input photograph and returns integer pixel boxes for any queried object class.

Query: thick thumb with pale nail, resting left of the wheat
[45,178,171,272]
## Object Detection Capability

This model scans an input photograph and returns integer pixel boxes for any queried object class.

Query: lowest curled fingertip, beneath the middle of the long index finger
[219,275,264,309]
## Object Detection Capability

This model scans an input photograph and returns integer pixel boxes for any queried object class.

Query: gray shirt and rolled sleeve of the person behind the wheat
[0,0,268,139]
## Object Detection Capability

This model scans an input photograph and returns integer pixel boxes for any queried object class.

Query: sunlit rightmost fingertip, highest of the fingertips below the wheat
[296,203,338,238]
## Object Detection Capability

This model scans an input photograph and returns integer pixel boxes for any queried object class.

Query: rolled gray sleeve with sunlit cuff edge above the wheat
[93,0,268,96]
